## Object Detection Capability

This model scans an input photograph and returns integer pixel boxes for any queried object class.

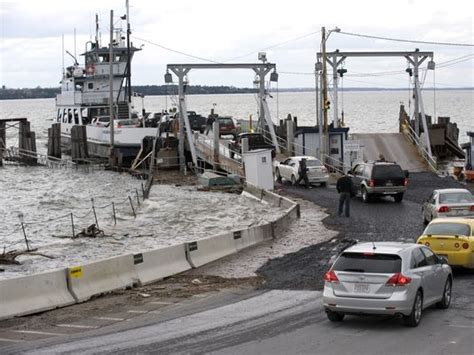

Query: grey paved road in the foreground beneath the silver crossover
[1,274,474,355]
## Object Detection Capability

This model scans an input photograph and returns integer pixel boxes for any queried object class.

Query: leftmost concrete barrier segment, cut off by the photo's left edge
[0,269,75,319]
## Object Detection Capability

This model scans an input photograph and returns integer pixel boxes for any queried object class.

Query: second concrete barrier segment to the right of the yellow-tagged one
[186,232,237,268]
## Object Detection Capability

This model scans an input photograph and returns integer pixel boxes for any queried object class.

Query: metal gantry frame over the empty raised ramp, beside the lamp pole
[316,49,434,156]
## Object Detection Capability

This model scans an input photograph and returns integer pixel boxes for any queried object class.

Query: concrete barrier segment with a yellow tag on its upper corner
[67,254,138,302]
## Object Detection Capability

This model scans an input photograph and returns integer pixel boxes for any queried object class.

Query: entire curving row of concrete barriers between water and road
[0,185,300,319]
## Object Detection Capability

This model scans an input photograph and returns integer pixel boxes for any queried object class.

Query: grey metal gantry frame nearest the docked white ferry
[165,62,279,172]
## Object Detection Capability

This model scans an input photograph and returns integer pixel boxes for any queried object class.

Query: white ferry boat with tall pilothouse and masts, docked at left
[53,12,157,162]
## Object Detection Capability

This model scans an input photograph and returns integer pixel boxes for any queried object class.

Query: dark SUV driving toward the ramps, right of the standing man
[349,161,408,202]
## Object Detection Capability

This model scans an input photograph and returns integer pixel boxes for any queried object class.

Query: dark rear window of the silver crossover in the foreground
[333,253,402,274]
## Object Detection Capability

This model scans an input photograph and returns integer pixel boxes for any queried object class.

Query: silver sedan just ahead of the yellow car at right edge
[421,189,474,224]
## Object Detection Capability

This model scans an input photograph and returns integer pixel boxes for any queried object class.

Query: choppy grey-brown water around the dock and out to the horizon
[0,91,474,278]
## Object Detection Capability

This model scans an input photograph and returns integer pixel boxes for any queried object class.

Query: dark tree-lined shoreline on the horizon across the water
[0,85,474,100]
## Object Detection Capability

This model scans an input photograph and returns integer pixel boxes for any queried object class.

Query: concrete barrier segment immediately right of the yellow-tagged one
[133,244,191,285]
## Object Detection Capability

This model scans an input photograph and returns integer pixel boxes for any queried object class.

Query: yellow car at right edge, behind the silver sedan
[417,218,474,268]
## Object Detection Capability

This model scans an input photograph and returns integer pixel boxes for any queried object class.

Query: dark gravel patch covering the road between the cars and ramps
[257,173,474,290]
